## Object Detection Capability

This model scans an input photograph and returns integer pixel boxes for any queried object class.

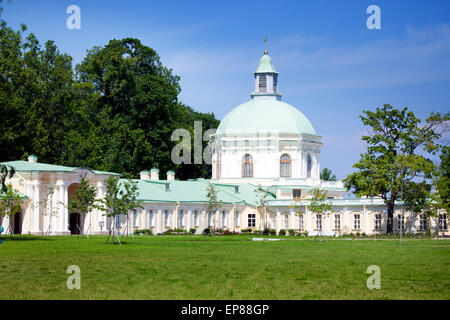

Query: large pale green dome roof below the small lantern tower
[217,99,316,135]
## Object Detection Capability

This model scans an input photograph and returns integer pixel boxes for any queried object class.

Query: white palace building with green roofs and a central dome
[0,50,448,235]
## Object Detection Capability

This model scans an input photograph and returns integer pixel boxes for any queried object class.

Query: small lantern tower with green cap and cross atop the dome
[251,37,281,100]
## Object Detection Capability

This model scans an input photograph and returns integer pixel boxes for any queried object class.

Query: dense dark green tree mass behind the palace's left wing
[0,21,219,179]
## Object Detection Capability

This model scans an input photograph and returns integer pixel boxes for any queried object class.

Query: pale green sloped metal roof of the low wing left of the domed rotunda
[119,179,274,206]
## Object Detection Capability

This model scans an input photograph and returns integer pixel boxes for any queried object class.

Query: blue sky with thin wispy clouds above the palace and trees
[2,0,450,178]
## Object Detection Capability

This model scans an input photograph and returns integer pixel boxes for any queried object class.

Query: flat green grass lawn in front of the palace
[0,236,450,300]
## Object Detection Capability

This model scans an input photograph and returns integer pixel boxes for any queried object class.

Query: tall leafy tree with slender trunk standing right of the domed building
[344,104,450,233]
